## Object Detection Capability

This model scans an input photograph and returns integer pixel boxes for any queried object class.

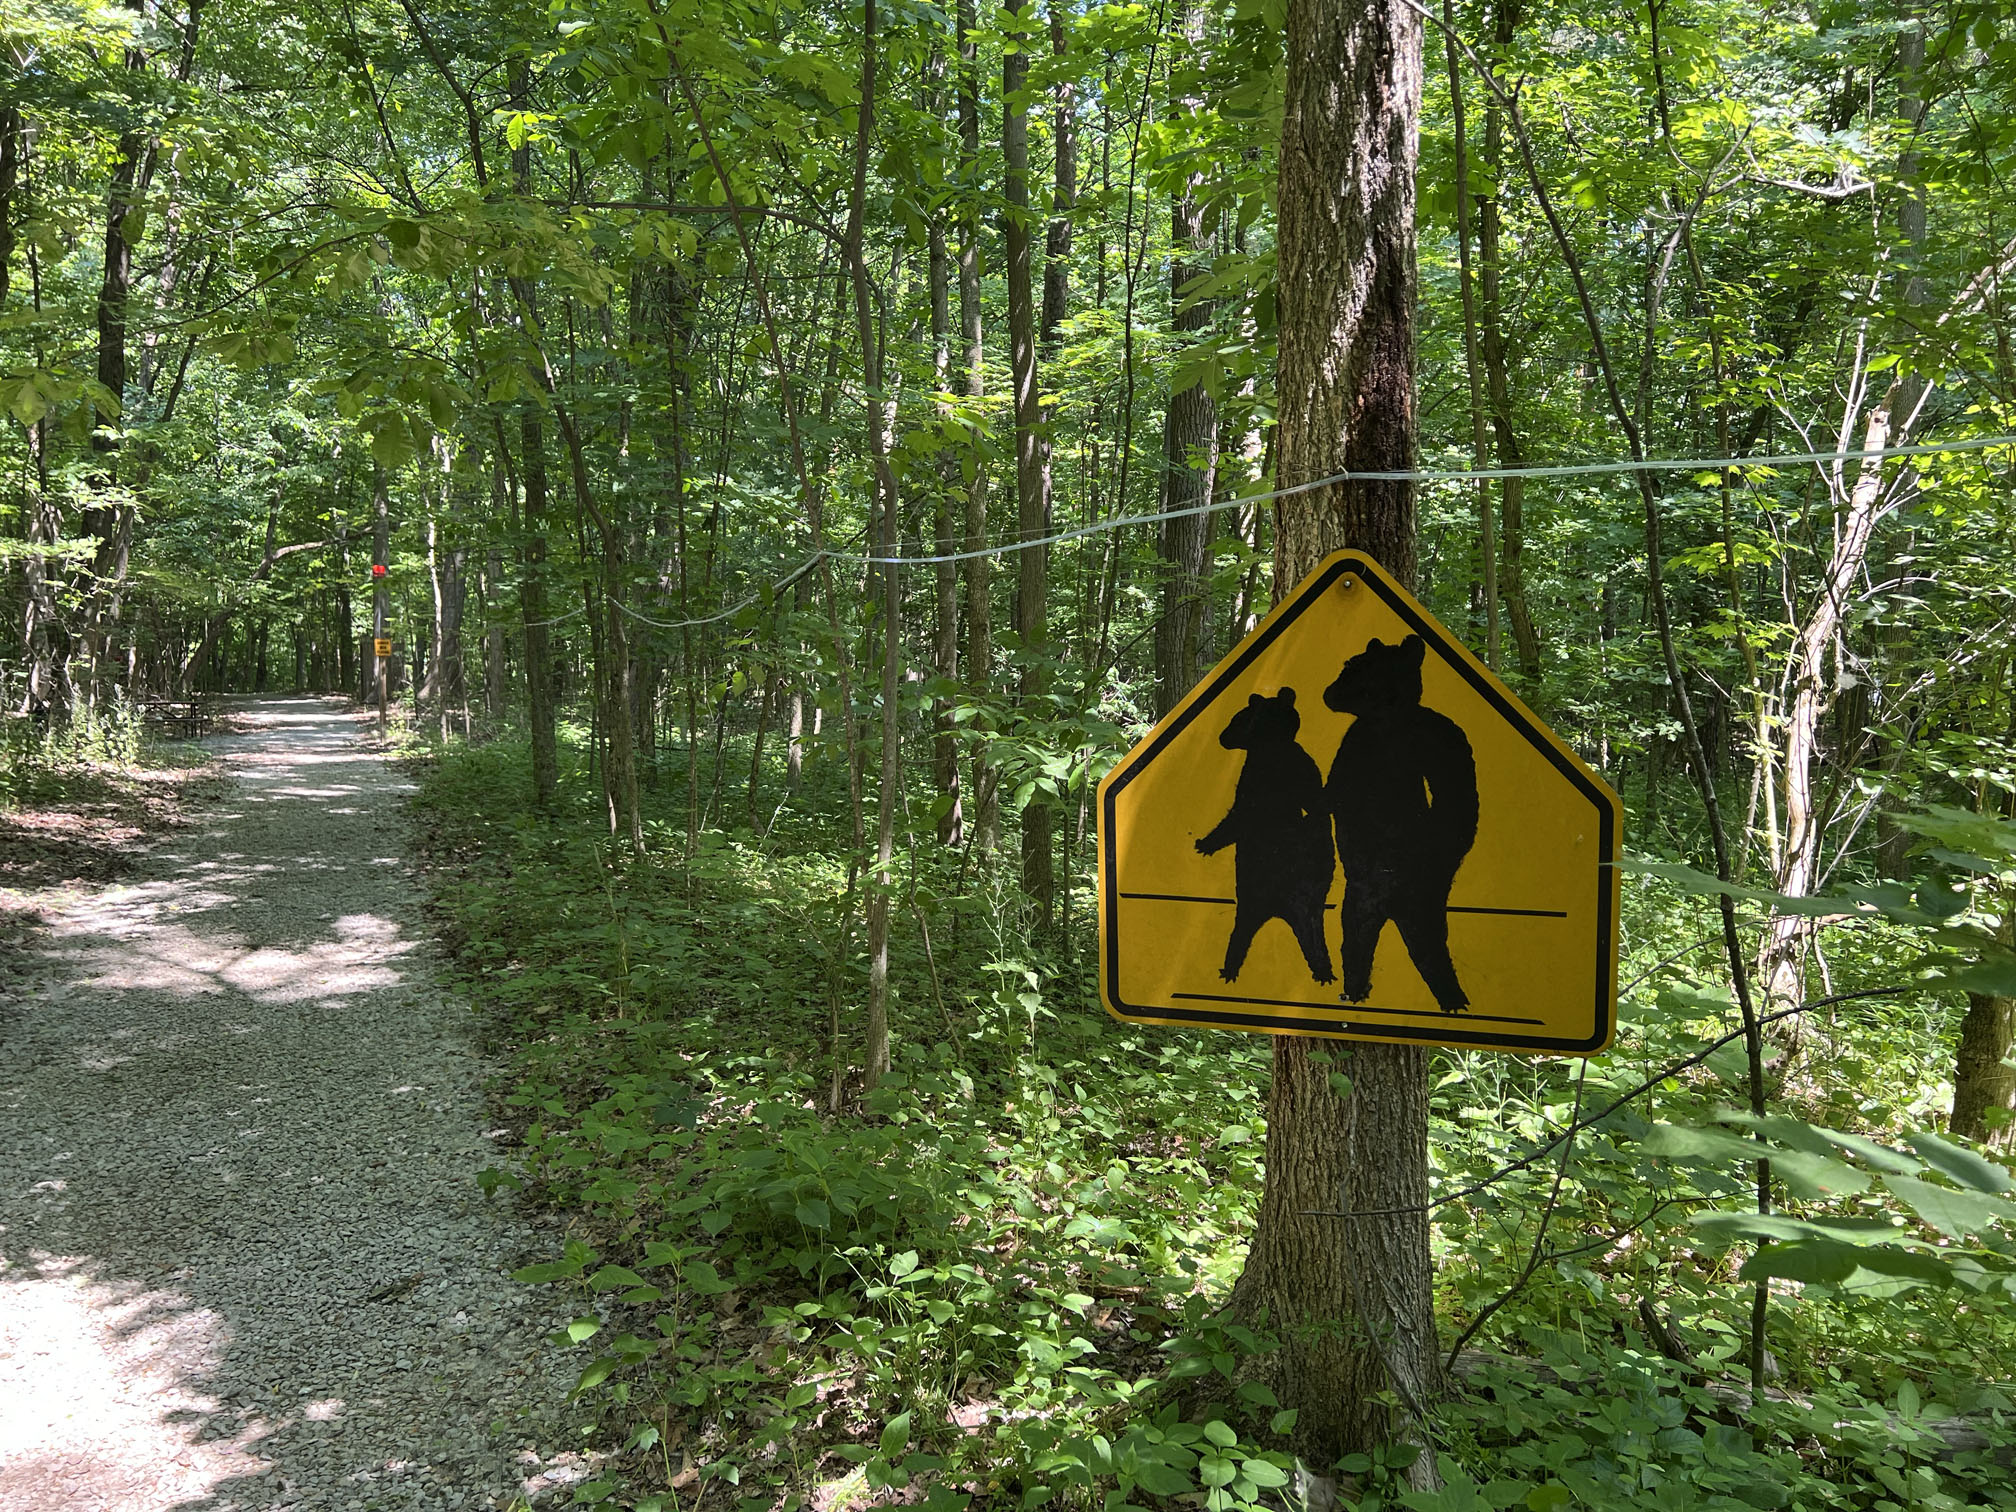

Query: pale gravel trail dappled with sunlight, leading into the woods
[0,698,585,1512]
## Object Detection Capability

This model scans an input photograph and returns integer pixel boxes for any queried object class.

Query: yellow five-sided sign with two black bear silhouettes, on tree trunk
[1099,550,1623,1054]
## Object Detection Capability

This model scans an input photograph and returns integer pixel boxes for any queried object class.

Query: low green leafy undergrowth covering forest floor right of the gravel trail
[419,744,2016,1512]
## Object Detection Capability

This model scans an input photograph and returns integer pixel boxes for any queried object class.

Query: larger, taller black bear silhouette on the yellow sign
[1322,635,1478,1014]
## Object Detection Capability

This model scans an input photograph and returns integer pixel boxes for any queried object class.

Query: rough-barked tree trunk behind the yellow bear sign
[1234,0,1439,1502]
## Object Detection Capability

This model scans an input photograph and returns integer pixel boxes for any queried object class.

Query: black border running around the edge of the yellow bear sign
[1101,556,1617,1054]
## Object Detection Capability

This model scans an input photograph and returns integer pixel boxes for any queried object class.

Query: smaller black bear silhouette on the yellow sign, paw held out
[1198,687,1337,982]
